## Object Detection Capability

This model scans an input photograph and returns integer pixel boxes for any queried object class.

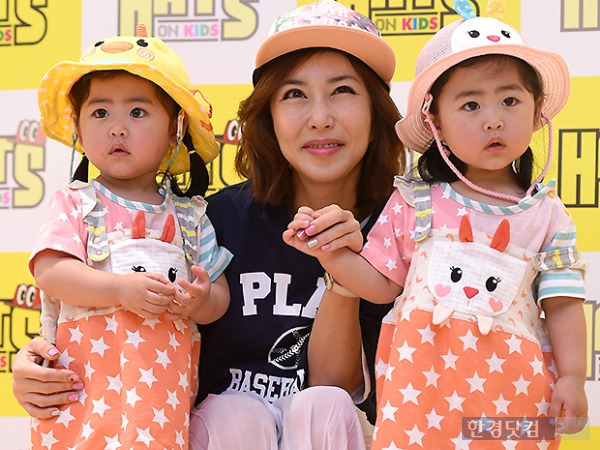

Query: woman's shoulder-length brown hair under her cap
[235,48,405,209]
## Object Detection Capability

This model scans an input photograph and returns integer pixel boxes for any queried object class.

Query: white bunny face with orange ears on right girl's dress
[427,216,528,334]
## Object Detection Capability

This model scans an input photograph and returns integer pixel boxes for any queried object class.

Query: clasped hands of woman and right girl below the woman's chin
[283,205,363,257]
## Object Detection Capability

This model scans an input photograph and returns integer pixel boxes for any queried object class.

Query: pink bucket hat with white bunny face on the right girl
[396,17,570,153]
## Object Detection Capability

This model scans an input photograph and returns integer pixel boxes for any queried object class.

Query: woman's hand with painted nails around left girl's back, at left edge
[12,338,83,419]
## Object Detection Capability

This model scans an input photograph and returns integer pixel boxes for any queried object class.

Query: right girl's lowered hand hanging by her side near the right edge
[548,376,588,434]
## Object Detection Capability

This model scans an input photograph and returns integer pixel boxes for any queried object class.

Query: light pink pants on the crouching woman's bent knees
[190,386,366,450]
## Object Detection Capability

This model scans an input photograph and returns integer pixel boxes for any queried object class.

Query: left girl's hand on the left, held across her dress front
[116,272,177,319]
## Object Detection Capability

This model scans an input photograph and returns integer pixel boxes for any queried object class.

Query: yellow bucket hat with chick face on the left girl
[38,25,220,175]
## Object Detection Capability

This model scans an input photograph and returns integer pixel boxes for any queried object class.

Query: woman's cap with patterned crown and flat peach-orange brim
[255,0,396,84]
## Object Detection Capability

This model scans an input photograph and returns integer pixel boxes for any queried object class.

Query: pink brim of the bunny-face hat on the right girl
[396,44,570,153]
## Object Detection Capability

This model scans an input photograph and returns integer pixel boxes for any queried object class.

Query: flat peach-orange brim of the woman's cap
[255,25,396,84]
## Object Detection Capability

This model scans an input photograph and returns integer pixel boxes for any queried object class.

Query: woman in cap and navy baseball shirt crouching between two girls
[13,0,404,449]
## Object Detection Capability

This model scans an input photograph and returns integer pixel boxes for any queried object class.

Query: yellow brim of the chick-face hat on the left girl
[38,60,220,175]
